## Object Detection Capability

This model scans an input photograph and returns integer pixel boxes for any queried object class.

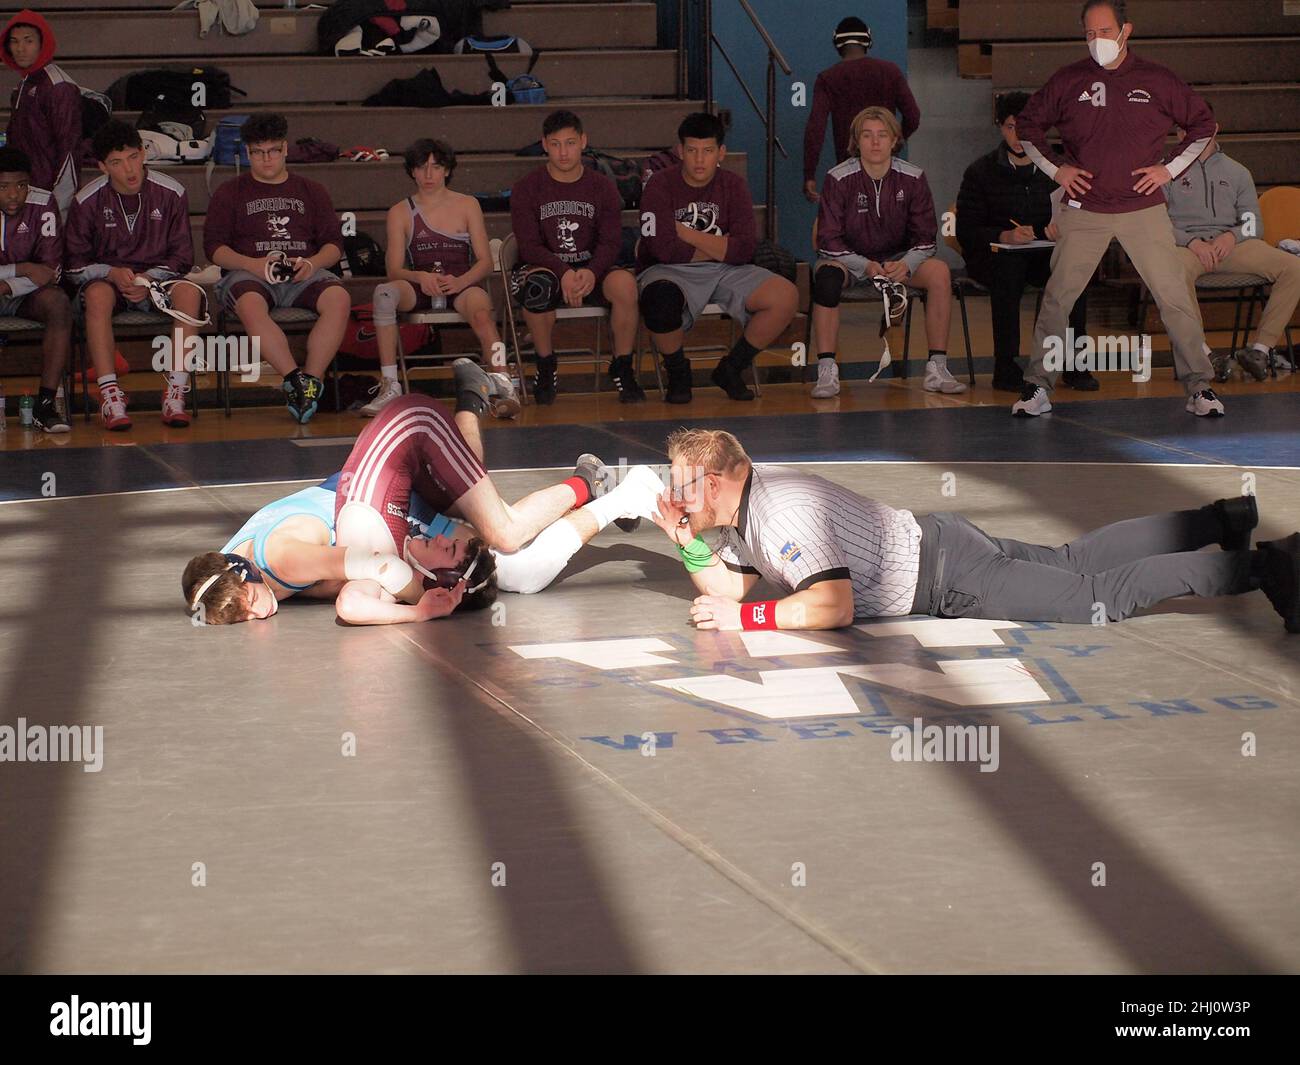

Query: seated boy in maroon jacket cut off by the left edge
[0,147,73,433]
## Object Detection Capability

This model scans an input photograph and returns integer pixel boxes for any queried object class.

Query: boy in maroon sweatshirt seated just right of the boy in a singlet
[510,111,646,404]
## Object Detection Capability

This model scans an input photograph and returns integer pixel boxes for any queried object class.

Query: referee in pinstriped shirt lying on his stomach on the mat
[655,429,1300,632]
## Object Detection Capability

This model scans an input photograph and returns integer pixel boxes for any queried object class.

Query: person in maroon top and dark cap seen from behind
[803,17,920,203]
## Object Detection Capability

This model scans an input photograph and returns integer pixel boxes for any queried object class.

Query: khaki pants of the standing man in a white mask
[1024,204,1214,395]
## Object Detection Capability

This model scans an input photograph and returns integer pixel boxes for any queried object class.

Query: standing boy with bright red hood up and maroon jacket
[0,10,82,217]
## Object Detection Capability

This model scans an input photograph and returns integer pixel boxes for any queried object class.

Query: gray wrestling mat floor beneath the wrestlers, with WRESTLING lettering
[0,463,1300,973]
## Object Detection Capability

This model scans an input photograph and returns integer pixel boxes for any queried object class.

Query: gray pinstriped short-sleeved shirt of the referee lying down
[716,466,920,618]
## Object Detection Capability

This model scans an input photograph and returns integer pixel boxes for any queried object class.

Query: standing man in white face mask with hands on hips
[1011,0,1223,416]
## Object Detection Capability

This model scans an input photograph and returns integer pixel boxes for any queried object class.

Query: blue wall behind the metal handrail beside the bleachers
[714,0,907,259]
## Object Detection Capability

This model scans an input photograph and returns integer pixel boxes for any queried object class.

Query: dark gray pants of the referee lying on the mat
[913,507,1256,624]
